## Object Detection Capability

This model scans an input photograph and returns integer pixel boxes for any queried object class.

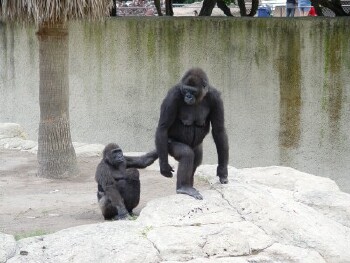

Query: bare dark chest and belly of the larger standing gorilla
[169,101,210,147]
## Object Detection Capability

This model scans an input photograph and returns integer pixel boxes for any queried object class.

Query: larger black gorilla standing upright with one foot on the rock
[156,68,229,199]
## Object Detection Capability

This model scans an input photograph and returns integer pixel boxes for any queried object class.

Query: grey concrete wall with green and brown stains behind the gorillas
[0,17,350,192]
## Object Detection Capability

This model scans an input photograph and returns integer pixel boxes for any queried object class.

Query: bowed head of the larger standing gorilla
[181,68,209,105]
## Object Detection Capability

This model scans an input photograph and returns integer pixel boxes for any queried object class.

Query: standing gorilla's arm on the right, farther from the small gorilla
[210,89,229,184]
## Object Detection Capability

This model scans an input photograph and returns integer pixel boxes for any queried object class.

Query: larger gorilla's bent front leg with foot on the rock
[168,141,203,199]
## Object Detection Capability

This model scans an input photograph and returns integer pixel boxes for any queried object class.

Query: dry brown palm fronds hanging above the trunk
[0,0,113,24]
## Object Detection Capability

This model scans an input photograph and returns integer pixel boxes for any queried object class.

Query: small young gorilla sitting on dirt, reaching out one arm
[95,143,158,219]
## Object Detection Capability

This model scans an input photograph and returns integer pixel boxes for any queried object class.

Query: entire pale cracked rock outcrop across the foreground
[0,165,350,263]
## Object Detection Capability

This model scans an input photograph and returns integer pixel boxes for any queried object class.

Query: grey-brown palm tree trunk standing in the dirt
[37,22,78,178]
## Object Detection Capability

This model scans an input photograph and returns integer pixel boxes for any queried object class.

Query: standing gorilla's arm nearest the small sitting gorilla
[156,86,180,177]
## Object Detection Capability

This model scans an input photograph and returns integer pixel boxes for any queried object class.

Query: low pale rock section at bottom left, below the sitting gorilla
[7,221,160,263]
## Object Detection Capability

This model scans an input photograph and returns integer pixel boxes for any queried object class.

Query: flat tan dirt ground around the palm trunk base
[0,149,208,238]
